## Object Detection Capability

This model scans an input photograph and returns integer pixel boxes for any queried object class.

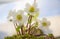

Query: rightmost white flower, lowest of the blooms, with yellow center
[40,18,51,34]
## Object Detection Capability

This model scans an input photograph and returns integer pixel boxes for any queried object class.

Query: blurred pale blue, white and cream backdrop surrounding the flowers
[0,0,60,39]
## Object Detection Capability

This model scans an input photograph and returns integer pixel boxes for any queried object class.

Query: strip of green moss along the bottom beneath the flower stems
[5,34,45,39]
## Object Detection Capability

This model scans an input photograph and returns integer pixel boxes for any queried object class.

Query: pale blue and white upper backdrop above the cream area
[0,0,60,21]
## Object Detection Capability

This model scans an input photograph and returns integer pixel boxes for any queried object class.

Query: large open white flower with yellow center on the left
[9,10,27,25]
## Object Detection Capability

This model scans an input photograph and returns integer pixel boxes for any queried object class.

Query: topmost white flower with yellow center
[25,3,39,15]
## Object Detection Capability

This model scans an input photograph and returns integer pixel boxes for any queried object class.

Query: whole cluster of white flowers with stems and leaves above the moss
[8,2,52,38]
